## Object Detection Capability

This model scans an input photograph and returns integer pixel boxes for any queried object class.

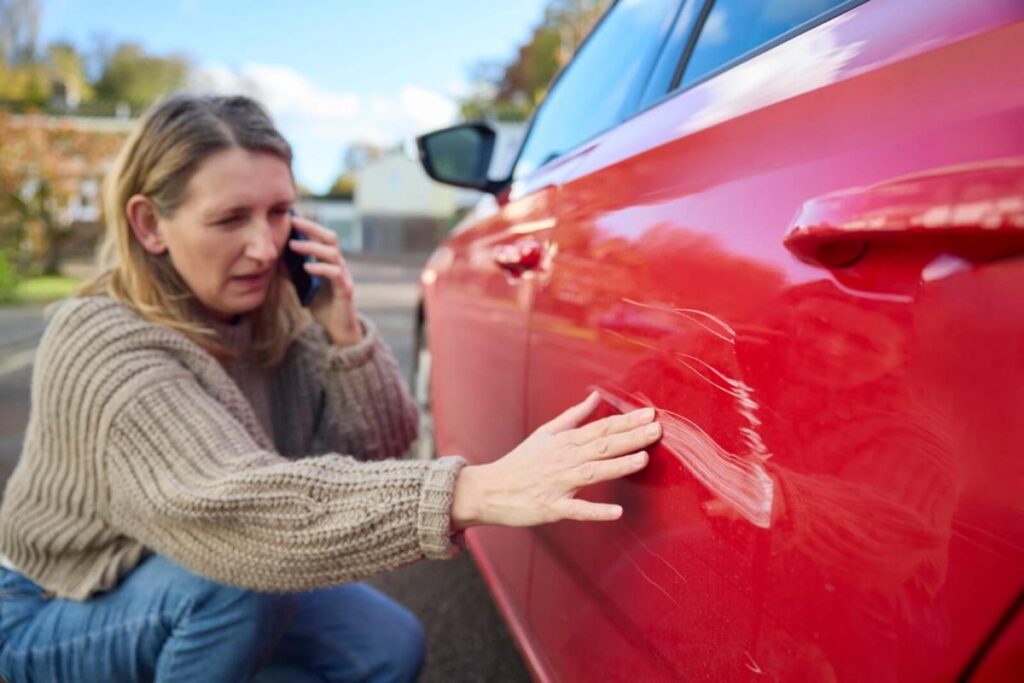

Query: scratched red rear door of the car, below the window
[526,0,1024,680]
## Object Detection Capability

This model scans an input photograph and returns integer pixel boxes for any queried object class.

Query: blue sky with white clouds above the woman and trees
[40,0,547,191]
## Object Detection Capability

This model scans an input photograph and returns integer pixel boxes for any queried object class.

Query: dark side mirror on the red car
[416,123,506,194]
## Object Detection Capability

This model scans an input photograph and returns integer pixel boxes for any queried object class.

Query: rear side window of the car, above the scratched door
[679,0,849,87]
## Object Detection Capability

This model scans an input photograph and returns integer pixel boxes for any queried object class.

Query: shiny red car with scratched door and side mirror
[411,0,1024,682]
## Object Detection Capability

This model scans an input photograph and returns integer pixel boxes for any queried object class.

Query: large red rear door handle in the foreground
[784,159,1024,267]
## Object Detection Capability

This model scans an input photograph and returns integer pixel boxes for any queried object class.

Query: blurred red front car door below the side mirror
[424,121,593,643]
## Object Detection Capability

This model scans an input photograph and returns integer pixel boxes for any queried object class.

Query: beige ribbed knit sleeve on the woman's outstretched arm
[105,368,465,591]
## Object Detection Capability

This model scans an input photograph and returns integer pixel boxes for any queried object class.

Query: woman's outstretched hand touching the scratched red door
[452,391,662,530]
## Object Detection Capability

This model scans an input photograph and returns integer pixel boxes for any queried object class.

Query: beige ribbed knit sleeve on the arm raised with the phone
[292,317,418,460]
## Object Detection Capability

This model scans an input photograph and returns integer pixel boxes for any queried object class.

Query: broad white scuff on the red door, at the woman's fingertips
[595,387,774,528]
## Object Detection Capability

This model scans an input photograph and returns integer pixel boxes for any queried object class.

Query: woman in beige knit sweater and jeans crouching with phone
[0,96,659,683]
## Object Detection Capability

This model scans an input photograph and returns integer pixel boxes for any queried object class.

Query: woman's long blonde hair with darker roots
[75,95,311,368]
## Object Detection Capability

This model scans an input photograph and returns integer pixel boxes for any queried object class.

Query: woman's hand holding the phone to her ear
[289,216,362,346]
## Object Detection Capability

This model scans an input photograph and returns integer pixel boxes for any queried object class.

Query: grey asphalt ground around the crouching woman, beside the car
[0,257,529,683]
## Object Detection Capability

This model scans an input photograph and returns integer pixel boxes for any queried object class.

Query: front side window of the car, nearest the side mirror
[514,0,678,178]
